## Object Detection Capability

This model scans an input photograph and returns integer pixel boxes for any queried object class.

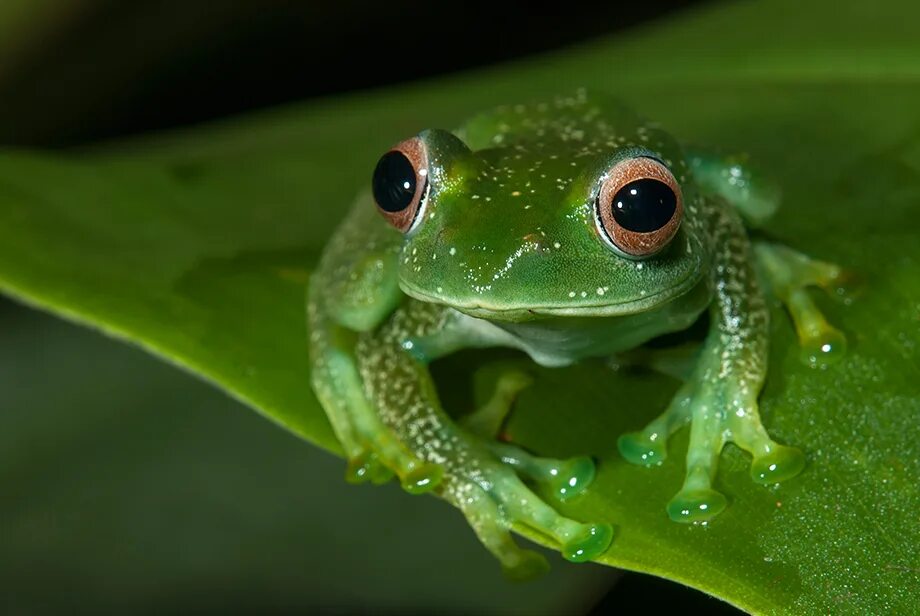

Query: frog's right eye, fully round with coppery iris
[595,156,684,259]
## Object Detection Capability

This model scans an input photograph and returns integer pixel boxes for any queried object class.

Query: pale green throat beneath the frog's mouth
[493,281,711,366]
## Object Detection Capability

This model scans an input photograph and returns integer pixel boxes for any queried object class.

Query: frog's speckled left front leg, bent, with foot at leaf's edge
[356,300,612,577]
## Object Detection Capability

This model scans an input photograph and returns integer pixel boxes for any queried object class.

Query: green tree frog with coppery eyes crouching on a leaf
[308,90,846,579]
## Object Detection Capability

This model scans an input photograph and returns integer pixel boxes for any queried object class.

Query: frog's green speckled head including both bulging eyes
[373,96,708,321]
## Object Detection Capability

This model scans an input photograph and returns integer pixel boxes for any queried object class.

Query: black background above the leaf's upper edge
[0,0,701,146]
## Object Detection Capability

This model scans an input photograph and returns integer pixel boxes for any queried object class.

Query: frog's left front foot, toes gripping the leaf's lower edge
[445,454,613,579]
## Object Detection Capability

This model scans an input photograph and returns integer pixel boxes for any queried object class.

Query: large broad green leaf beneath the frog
[0,1,920,614]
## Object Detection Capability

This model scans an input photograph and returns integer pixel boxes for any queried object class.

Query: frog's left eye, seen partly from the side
[372,137,428,233]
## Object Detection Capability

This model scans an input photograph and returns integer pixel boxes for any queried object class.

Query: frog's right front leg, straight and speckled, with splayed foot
[619,209,805,522]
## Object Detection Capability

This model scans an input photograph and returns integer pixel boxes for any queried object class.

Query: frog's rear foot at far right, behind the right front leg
[754,243,853,367]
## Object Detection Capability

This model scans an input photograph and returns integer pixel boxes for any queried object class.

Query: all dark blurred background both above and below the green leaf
[0,0,737,614]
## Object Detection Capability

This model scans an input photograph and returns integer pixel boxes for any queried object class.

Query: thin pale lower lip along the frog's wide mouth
[400,272,703,323]
